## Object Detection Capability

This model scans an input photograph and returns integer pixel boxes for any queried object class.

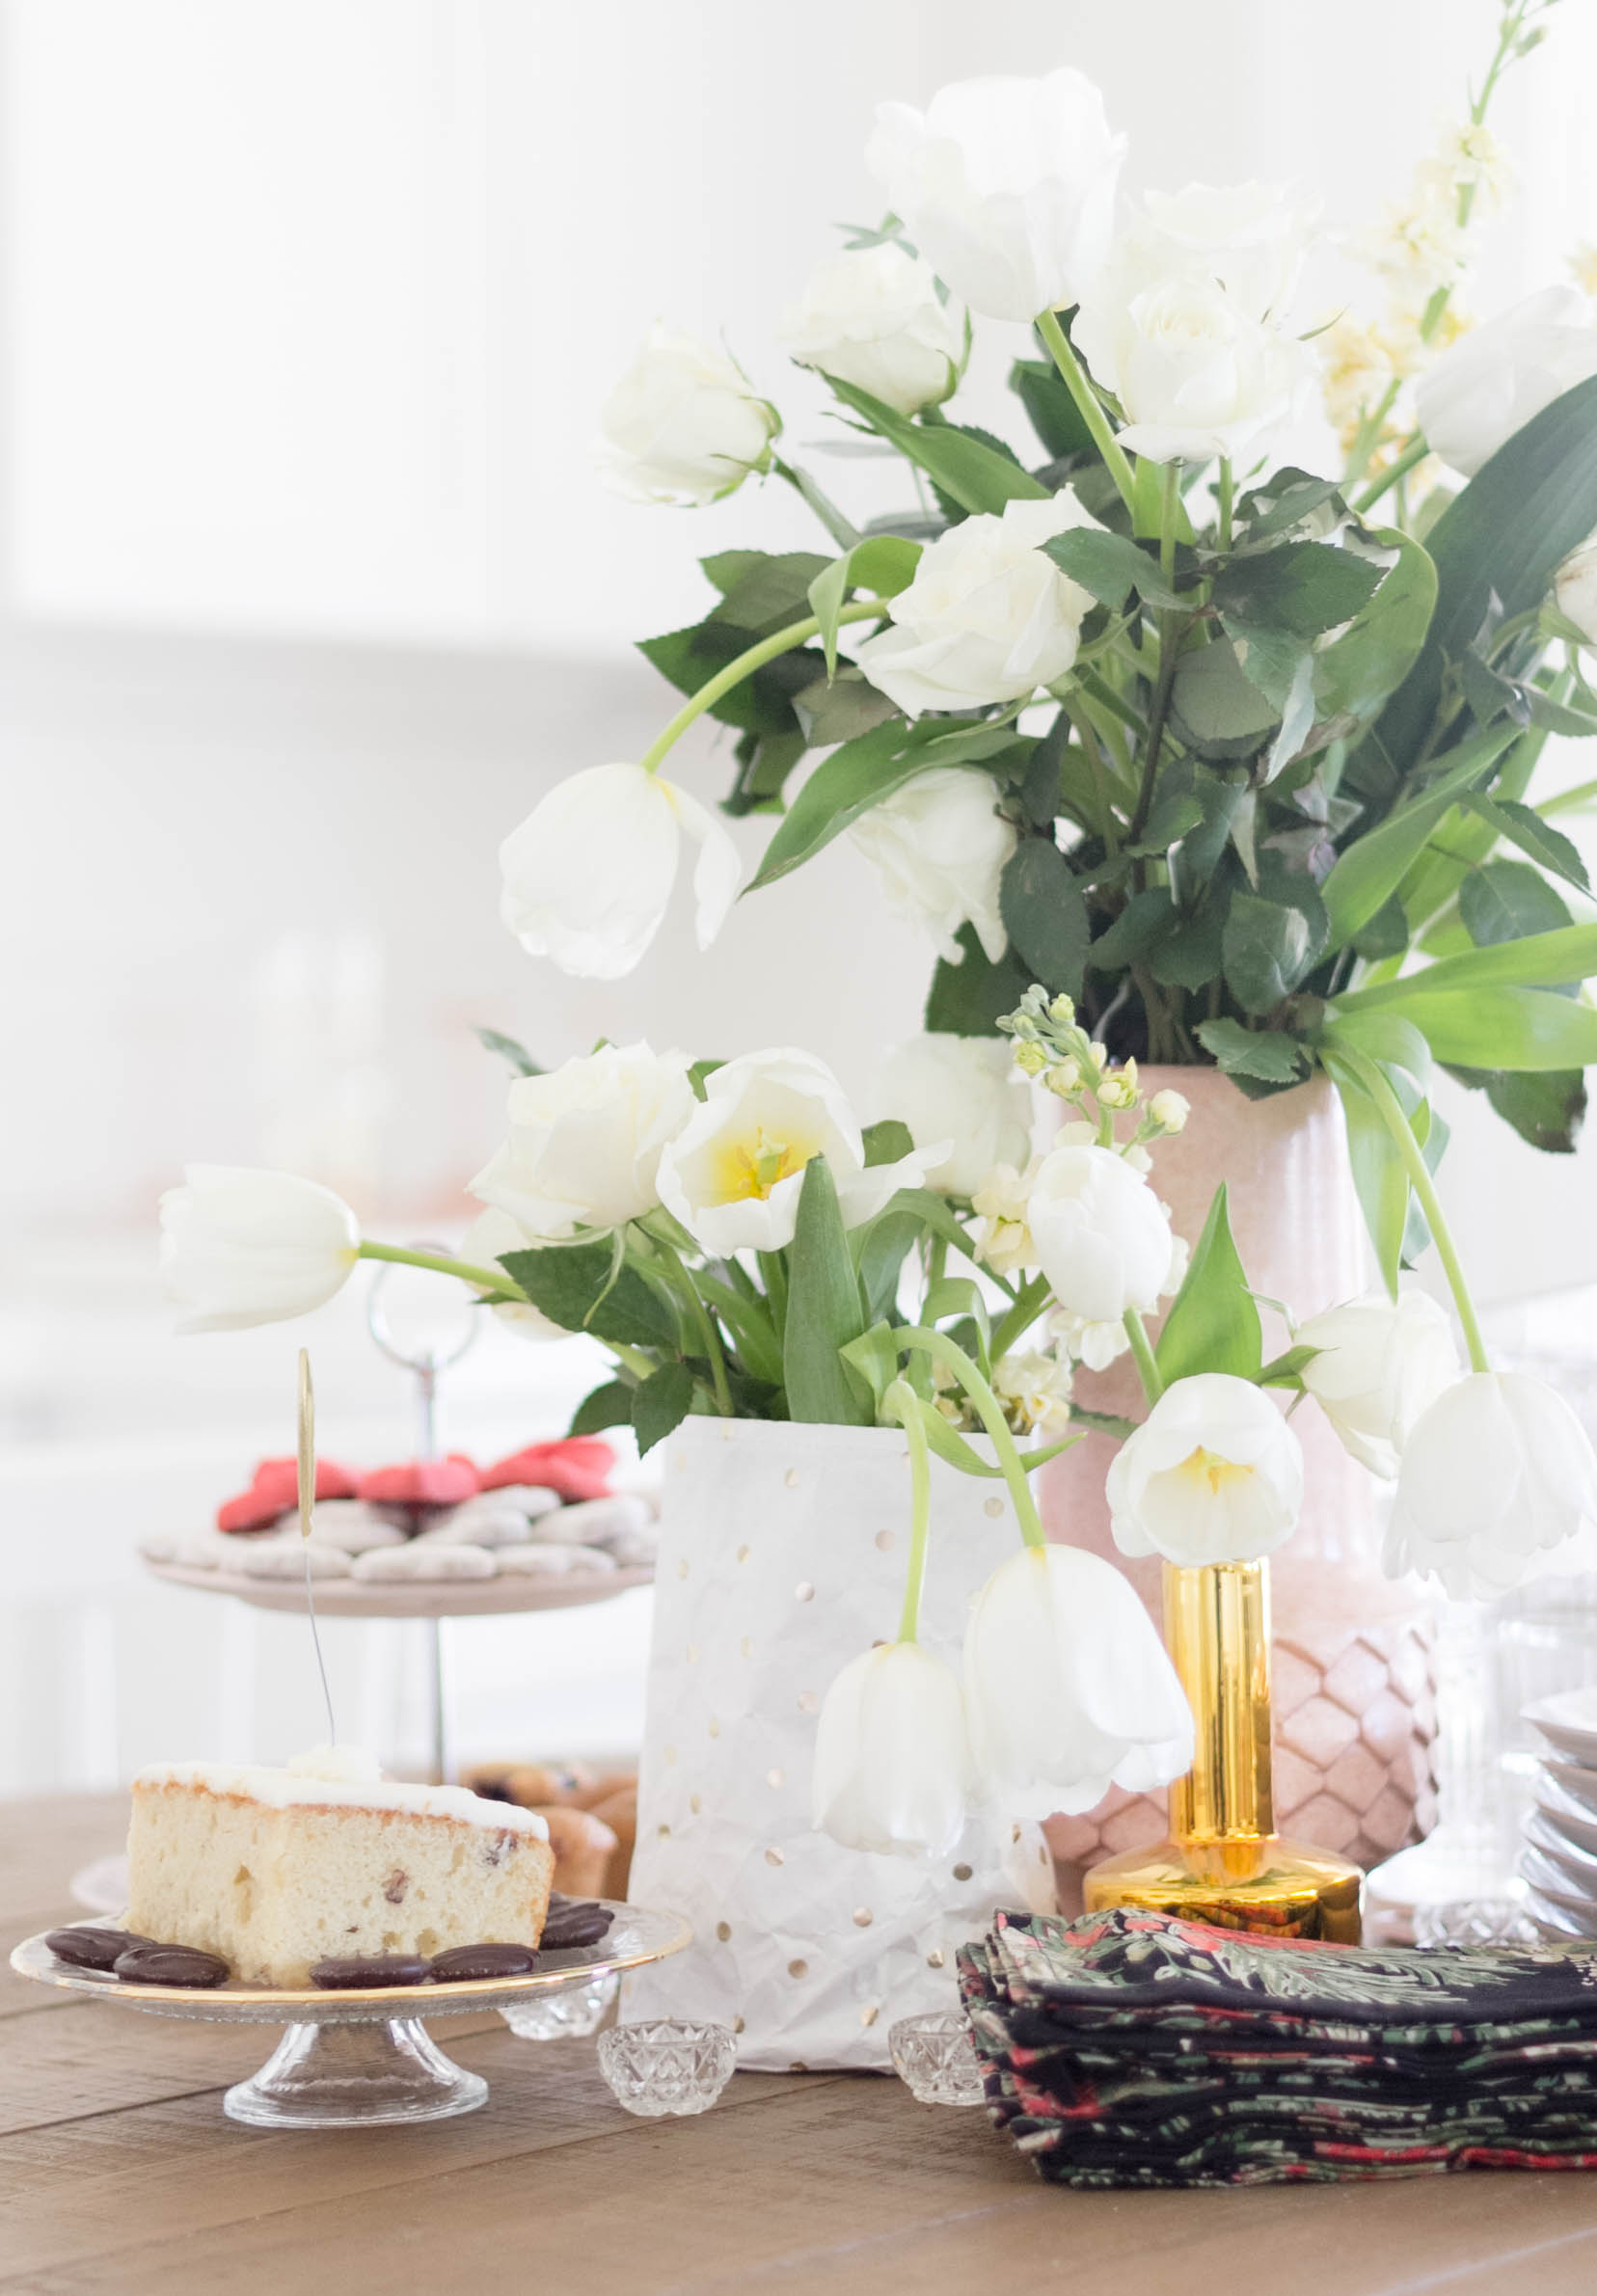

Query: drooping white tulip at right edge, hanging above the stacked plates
[1381,1370,1597,1601]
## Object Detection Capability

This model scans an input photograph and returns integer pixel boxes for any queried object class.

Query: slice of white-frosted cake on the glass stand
[128,1747,555,1986]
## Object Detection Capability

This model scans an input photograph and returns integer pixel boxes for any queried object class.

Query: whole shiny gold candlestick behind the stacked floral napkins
[1085,1563,1363,1945]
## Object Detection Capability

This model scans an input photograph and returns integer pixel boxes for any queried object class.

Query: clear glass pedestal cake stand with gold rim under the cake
[12,1905,693,2128]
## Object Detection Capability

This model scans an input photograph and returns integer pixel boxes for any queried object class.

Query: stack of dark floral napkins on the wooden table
[960,1912,1597,2186]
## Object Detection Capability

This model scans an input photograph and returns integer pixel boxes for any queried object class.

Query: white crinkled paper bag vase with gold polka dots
[622,1418,1053,2071]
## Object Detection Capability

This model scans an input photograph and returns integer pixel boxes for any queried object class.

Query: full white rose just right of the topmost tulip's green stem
[1074,245,1314,462]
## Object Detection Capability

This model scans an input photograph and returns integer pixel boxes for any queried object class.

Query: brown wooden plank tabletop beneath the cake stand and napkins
[0,1796,1597,2296]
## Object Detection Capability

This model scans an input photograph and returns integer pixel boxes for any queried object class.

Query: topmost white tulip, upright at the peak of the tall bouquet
[865,68,1126,319]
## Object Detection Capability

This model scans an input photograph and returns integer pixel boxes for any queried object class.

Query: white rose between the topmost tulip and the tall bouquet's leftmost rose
[782,239,963,416]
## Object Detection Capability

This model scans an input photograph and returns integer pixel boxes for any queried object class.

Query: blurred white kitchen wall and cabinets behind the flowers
[0,0,1597,1791]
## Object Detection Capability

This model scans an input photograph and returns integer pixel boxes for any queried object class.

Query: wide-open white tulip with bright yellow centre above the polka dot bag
[659,1049,922,1254]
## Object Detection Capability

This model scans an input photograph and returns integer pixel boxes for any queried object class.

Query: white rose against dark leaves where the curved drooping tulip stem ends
[855,487,1103,716]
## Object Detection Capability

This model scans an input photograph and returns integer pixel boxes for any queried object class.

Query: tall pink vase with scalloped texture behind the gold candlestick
[1044,1067,1436,1897]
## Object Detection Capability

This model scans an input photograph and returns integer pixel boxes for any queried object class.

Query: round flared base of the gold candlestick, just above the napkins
[1083,1834,1363,1945]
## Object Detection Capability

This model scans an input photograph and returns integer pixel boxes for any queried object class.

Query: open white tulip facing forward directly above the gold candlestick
[1106,1370,1303,1571]
